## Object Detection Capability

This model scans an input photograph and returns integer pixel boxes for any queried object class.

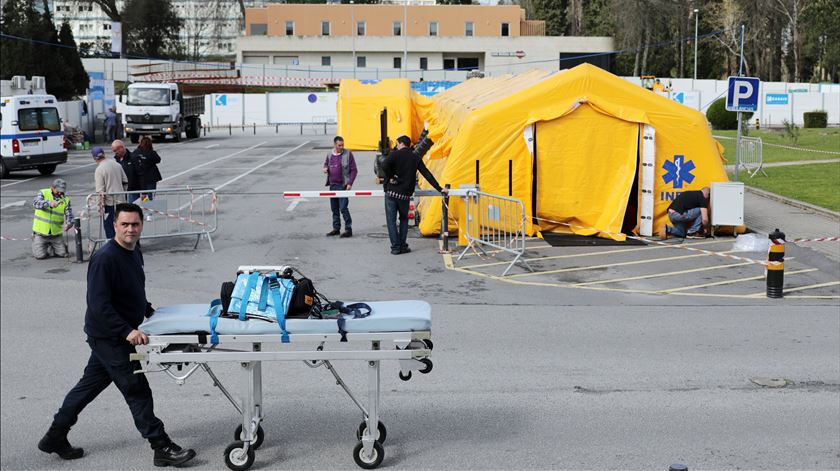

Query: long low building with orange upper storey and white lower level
[236,4,613,79]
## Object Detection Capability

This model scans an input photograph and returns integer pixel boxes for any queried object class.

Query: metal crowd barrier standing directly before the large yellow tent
[458,190,534,276]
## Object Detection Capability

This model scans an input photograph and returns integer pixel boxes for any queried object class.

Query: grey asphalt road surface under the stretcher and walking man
[0,129,840,470]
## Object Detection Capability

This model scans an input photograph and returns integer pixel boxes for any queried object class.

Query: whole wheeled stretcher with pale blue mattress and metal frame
[132,267,433,470]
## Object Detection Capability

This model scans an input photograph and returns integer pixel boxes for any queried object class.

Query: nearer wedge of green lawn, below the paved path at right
[729,162,840,211]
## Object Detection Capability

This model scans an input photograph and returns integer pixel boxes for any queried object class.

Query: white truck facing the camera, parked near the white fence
[121,82,204,144]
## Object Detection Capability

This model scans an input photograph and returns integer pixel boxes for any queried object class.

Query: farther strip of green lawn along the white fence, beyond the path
[712,128,840,164]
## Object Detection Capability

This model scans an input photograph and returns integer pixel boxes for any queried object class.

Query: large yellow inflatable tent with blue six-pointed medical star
[420,64,727,240]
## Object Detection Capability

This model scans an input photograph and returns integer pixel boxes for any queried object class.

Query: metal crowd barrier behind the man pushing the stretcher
[84,187,218,253]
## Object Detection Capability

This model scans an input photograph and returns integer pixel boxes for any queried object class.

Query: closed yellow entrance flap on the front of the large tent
[534,104,639,240]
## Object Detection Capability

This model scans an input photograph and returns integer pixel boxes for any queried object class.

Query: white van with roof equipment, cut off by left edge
[0,76,67,178]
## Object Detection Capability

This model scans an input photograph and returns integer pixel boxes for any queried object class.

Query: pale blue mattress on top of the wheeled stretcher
[140,301,432,335]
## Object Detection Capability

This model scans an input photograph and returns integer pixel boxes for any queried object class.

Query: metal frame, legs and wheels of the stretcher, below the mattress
[131,331,433,471]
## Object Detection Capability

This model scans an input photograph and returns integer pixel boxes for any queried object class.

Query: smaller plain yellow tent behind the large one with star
[336,79,424,150]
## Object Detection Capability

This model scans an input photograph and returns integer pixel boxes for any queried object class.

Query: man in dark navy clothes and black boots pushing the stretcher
[38,203,195,466]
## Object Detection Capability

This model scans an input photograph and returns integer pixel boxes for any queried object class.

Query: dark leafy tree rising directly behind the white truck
[121,0,183,58]
